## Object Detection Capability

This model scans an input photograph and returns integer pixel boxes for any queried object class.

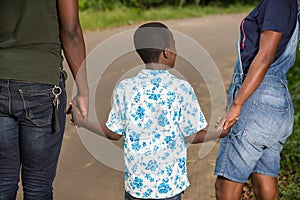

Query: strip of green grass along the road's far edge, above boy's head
[80,4,253,30]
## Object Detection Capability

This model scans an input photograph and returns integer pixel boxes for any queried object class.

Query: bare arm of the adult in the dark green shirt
[57,0,89,119]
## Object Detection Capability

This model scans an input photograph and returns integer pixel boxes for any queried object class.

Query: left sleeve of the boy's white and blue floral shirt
[106,83,126,135]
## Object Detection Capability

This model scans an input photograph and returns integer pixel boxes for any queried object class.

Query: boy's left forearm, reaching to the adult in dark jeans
[72,107,122,140]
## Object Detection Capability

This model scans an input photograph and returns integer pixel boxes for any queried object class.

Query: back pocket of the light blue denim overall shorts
[244,92,289,147]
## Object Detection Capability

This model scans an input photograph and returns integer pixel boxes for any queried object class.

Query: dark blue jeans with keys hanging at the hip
[0,76,66,200]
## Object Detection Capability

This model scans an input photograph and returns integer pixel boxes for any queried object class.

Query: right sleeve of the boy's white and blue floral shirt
[179,84,207,137]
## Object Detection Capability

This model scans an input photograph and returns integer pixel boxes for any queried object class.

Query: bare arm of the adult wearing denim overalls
[217,31,282,130]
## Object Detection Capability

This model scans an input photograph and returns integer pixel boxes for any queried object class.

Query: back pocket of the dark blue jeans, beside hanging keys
[19,85,54,126]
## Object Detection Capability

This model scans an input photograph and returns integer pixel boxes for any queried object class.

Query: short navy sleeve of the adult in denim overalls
[261,0,291,33]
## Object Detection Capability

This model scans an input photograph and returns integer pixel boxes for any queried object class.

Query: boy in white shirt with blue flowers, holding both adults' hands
[73,22,226,200]
